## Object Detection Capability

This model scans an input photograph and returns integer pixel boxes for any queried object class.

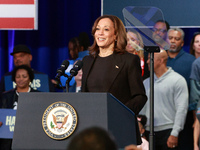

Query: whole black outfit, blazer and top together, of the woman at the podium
[81,52,147,114]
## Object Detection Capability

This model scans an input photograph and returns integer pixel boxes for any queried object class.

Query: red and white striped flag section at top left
[0,0,38,30]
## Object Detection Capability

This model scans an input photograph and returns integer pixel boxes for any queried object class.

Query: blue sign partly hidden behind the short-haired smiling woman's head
[4,73,49,92]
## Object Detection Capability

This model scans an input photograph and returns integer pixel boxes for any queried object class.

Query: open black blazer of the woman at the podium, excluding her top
[82,52,147,115]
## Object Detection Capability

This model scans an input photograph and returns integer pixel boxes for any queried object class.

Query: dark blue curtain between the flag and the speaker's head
[0,0,101,78]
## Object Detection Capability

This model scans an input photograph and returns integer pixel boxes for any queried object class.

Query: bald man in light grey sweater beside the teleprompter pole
[140,50,188,150]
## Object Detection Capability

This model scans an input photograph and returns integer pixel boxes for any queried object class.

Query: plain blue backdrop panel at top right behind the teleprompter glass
[103,0,200,27]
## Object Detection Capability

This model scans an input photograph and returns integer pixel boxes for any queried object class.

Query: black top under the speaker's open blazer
[87,55,113,92]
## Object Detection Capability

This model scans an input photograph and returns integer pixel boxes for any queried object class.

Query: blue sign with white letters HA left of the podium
[0,109,16,139]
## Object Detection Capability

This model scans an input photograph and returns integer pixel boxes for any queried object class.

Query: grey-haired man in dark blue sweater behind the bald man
[167,28,195,150]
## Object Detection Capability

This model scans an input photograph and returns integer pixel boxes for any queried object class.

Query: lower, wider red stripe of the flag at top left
[0,18,34,29]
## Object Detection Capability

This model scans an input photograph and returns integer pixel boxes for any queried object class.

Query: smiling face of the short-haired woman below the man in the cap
[15,69,30,89]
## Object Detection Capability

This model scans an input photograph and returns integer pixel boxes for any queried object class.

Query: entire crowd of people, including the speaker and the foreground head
[0,15,200,150]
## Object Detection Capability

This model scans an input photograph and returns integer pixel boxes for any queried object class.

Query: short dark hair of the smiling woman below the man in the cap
[12,65,34,82]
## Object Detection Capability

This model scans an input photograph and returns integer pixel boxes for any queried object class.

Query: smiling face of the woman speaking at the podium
[94,18,116,50]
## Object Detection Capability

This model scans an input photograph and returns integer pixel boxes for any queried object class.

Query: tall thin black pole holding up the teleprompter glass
[144,46,160,150]
